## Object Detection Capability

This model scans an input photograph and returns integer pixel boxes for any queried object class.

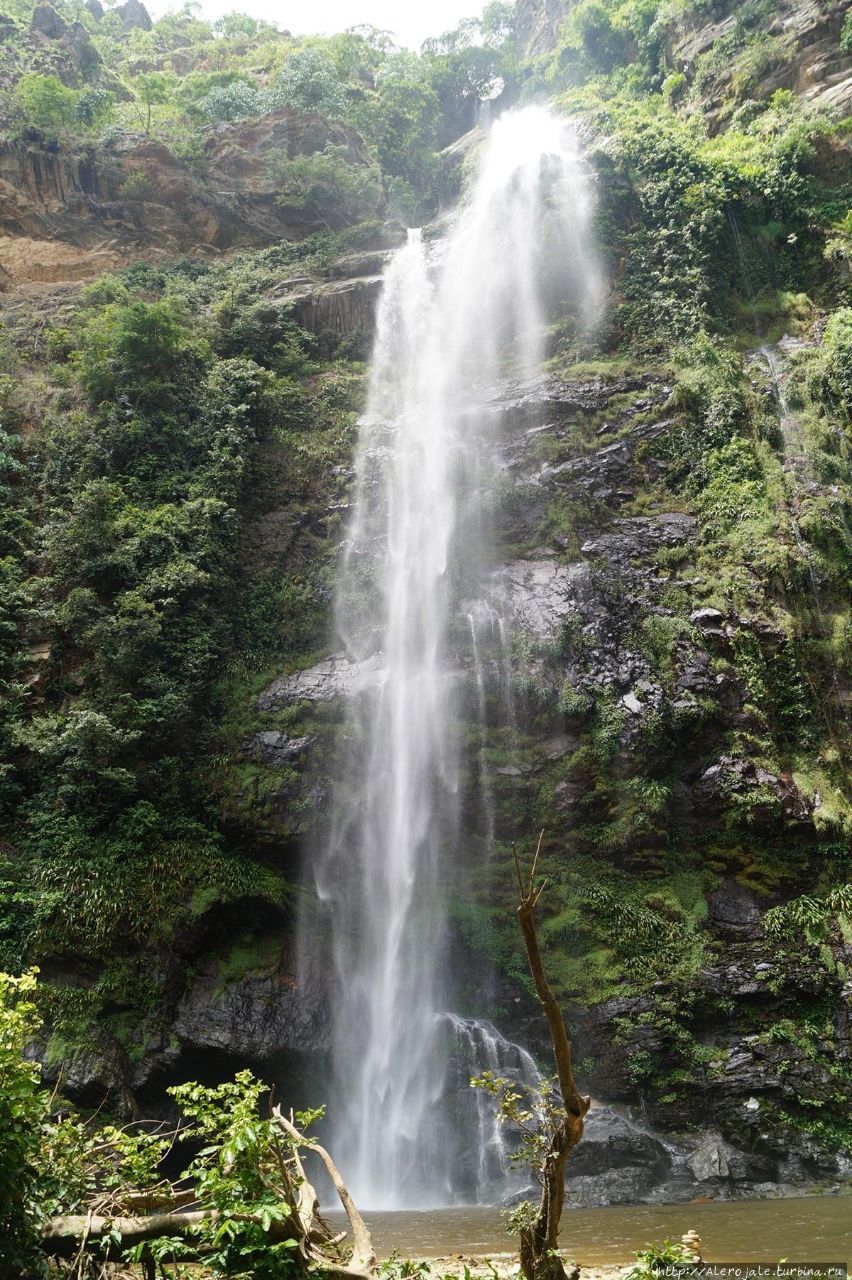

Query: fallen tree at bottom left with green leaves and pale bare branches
[0,970,376,1280]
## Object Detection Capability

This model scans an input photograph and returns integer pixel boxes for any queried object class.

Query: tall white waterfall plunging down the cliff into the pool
[316,108,596,1208]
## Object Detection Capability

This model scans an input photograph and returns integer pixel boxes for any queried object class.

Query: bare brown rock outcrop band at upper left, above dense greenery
[0,110,375,285]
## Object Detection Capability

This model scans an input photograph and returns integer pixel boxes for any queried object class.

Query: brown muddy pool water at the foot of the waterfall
[330,1196,852,1266]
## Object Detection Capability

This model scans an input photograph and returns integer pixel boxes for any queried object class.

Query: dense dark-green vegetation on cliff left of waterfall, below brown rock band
[0,237,359,1051]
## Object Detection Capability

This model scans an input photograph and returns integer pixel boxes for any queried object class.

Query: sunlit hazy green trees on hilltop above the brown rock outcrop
[0,0,519,216]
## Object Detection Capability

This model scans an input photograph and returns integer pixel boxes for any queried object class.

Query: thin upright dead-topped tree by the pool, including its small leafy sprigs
[471,832,591,1280]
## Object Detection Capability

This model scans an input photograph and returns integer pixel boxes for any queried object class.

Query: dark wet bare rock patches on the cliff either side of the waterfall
[164,350,834,1207]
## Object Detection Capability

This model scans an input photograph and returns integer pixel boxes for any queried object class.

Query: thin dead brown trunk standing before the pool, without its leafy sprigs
[513,832,591,1280]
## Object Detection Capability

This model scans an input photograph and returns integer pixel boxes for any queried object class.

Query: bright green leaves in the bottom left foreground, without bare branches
[0,970,308,1280]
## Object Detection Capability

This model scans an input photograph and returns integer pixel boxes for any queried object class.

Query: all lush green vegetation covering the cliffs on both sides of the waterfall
[0,0,852,1249]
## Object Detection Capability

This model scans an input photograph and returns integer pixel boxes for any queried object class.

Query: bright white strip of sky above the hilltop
[148,0,486,49]
